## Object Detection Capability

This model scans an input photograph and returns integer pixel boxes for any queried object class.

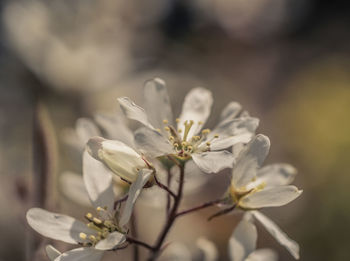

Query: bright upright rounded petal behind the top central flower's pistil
[178,87,213,137]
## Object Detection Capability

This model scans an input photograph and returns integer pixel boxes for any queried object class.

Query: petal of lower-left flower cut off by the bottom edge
[55,247,104,261]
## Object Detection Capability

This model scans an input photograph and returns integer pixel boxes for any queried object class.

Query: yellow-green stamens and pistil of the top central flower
[163,119,219,159]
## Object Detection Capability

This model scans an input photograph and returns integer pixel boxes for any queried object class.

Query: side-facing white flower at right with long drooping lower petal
[228,134,302,259]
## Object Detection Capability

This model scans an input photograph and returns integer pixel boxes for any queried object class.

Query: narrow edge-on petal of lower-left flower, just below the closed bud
[119,169,153,226]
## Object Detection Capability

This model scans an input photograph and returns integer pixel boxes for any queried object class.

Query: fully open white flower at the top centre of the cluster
[118,78,258,173]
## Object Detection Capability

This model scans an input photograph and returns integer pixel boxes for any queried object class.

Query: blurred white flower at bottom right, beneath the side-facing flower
[229,213,277,261]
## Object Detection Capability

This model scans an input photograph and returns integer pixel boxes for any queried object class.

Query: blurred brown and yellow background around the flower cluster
[0,0,350,261]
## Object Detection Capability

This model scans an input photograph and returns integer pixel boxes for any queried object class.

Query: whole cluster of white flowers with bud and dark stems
[27,78,302,261]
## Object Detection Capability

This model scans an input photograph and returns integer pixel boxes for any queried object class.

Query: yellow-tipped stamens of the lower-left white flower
[79,207,120,247]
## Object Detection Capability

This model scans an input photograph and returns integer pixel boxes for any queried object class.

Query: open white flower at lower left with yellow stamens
[27,149,152,261]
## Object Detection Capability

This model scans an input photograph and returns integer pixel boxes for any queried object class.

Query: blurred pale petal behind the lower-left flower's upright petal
[60,171,91,207]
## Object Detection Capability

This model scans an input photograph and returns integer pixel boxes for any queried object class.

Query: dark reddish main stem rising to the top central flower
[148,163,185,261]
